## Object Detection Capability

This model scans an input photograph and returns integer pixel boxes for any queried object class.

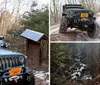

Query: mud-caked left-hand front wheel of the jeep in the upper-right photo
[59,16,68,33]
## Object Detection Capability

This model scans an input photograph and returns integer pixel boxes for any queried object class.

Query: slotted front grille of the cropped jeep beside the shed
[0,57,20,69]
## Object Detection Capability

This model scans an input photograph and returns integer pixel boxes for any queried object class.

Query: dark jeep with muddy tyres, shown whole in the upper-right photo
[59,4,96,37]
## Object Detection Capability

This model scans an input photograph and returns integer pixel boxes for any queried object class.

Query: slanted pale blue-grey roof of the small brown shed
[21,29,47,42]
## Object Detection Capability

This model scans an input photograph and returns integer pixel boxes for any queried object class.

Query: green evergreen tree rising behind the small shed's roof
[21,2,49,35]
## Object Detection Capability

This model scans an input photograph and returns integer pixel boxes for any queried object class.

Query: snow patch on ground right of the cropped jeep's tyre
[34,71,50,85]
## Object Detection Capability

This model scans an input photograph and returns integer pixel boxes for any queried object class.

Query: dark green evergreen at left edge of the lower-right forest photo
[51,43,72,85]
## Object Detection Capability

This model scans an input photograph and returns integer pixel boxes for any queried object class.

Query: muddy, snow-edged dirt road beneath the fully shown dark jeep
[50,24,100,41]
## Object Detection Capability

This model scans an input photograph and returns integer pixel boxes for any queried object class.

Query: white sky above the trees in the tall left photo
[0,0,49,13]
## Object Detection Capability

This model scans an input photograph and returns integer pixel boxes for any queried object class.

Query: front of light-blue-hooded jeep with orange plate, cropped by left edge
[0,48,35,85]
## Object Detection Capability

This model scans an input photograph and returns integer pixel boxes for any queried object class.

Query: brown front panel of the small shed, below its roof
[27,40,41,69]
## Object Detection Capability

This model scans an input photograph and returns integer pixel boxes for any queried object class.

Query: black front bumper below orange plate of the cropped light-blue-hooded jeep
[0,67,31,85]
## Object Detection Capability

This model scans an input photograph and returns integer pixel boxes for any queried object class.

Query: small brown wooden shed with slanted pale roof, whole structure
[21,29,48,69]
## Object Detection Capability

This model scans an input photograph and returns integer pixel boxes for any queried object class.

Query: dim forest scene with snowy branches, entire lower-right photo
[51,43,100,85]
